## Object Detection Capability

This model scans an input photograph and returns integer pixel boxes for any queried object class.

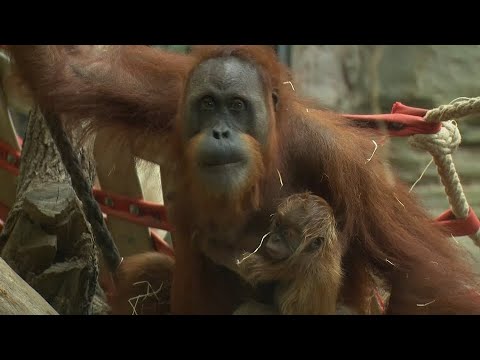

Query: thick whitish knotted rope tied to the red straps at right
[409,97,480,247]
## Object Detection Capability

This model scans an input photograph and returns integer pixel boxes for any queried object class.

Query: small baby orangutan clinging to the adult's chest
[235,193,346,315]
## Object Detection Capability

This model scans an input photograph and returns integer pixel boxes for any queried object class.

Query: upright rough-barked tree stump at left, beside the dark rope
[0,111,105,314]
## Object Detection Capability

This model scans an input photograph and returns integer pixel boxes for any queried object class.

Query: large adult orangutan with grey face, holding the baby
[9,46,480,314]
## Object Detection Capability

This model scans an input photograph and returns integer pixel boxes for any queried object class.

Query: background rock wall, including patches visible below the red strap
[291,45,480,184]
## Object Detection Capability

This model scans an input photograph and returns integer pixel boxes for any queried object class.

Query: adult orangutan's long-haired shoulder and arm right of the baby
[280,102,480,314]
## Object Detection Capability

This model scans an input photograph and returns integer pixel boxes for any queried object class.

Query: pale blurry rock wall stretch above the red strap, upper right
[291,45,480,115]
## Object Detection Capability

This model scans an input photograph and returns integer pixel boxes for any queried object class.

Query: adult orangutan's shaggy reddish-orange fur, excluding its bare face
[9,45,480,314]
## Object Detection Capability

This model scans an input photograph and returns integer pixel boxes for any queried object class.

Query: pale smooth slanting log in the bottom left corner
[0,258,58,315]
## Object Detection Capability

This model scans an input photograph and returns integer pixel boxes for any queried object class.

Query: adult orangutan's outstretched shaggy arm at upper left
[8,45,192,153]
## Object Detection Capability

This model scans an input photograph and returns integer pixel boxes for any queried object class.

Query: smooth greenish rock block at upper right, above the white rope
[377,45,480,109]
